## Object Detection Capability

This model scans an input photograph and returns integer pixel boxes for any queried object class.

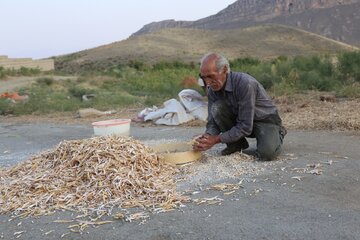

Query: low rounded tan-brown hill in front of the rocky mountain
[55,25,357,71]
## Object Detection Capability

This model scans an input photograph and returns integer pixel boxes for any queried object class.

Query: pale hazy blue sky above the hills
[0,0,236,59]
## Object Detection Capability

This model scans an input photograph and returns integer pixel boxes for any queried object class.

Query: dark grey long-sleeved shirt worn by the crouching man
[206,72,277,143]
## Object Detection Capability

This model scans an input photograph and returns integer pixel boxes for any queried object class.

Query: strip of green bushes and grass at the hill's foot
[0,52,360,115]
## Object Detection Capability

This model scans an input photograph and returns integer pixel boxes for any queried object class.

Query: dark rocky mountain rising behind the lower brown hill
[134,0,360,46]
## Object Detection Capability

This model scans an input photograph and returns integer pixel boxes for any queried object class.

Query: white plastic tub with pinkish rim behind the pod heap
[92,119,131,136]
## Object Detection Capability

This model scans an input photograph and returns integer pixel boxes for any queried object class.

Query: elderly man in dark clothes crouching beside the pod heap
[193,53,286,160]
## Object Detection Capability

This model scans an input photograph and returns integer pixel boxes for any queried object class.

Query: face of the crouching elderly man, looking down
[199,59,227,92]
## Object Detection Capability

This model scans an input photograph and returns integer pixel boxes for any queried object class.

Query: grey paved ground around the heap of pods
[0,123,360,240]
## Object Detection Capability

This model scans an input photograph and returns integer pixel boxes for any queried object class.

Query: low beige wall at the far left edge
[0,55,54,71]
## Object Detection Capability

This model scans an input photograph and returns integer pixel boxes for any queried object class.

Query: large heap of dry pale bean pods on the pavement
[0,136,186,216]
